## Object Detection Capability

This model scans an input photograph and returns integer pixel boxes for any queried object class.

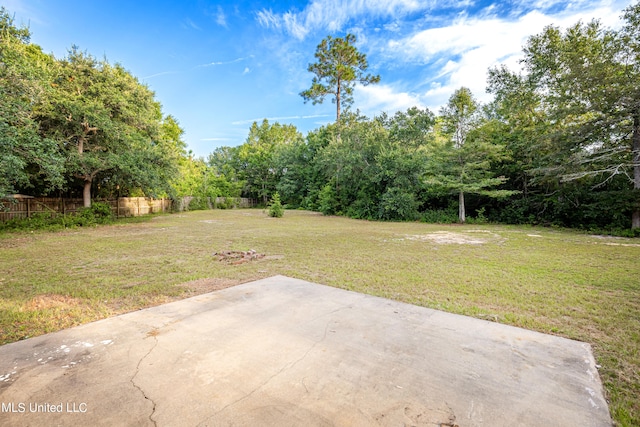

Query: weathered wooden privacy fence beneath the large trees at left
[0,195,171,221]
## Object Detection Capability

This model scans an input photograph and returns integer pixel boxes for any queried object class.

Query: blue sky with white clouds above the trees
[0,0,633,157]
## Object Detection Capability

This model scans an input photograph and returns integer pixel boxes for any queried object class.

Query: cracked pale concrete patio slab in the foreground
[0,276,612,427]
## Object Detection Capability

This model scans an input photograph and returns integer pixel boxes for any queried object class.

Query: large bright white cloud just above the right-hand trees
[386,2,620,111]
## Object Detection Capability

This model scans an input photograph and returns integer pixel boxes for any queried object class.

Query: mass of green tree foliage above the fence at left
[0,8,184,206]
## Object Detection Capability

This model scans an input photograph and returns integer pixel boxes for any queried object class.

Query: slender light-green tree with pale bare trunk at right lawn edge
[426,87,512,223]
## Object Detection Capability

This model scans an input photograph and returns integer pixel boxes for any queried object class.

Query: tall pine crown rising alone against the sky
[300,34,380,123]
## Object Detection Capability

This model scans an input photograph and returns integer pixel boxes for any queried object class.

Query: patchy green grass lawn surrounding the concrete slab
[0,210,640,426]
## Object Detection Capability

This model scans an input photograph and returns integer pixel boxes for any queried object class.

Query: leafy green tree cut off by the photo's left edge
[0,8,64,197]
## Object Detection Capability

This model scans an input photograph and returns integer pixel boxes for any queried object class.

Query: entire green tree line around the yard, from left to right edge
[0,3,640,234]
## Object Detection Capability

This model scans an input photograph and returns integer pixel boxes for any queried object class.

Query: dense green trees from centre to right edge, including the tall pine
[208,3,640,234]
